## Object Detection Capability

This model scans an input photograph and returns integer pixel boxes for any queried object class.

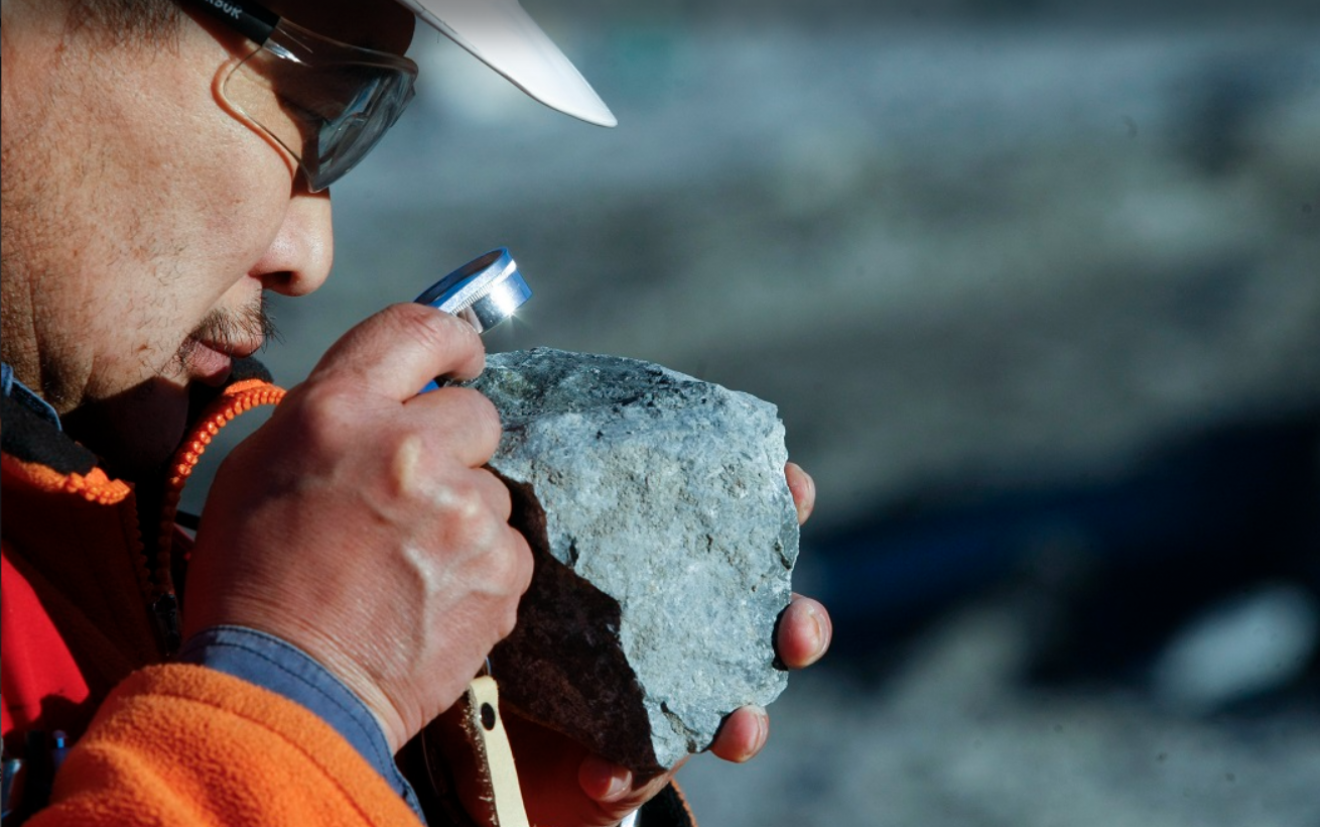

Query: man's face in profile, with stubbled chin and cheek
[0,0,413,476]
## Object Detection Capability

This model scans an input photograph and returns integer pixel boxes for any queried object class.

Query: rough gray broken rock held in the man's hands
[467,348,797,776]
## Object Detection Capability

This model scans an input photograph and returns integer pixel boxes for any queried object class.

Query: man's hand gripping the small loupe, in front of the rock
[185,305,532,750]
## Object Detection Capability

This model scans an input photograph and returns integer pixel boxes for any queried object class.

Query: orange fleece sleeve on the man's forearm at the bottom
[29,665,418,827]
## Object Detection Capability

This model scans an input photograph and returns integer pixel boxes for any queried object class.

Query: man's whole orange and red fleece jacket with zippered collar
[0,381,418,827]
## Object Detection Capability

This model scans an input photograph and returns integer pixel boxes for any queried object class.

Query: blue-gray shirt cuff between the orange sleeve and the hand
[174,627,426,824]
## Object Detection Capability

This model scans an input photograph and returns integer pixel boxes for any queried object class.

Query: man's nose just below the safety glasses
[253,187,334,295]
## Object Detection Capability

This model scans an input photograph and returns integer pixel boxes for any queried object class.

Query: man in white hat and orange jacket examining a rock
[0,0,829,826]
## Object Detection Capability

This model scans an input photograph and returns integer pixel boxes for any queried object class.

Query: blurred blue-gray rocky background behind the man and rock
[191,0,1320,827]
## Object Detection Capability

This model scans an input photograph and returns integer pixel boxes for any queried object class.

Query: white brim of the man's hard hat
[399,0,619,127]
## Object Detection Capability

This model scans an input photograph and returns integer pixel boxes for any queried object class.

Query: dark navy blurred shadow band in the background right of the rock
[804,412,1320,708]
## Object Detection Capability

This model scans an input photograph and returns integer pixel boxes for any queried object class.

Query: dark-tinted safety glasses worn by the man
[182,0,417,193]
